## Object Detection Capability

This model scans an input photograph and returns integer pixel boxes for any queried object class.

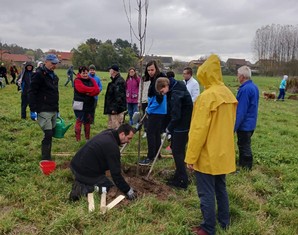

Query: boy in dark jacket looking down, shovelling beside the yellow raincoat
[155,72,193,189]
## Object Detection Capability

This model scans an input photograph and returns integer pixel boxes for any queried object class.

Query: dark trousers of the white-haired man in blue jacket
[237,131,254,170]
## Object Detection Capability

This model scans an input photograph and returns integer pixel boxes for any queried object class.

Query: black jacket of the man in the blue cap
[29,66,59,113]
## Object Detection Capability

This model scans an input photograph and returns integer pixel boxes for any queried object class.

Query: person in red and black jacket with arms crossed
[73,66,100,141]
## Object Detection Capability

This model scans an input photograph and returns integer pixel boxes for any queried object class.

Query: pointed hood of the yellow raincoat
[197,55,224,89]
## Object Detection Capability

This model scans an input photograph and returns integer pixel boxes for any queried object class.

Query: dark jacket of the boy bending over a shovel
[167,78,193,132]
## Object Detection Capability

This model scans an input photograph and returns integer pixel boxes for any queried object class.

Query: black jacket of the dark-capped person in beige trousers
[104,73,126,114]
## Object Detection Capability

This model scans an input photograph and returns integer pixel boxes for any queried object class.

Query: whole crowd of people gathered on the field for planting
[0,54,282,234]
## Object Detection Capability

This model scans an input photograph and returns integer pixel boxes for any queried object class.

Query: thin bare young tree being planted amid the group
[123,0,149,175]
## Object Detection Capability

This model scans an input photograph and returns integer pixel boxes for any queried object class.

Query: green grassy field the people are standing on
[0,70,298,235]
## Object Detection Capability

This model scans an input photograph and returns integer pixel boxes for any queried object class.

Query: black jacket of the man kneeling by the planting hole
[70,129,130,193]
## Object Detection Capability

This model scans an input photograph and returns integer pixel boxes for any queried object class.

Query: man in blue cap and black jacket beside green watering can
[29,54,59,160]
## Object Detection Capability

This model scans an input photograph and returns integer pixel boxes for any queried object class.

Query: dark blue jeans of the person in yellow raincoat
[195,171,230,235]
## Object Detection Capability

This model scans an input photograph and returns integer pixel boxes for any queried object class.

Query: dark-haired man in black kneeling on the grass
[70,124,136,201]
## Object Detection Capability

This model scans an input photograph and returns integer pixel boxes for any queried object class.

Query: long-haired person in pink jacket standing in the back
[126,67,140,125]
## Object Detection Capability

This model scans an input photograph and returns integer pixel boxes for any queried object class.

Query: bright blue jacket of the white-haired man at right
[235,80,259,131]
